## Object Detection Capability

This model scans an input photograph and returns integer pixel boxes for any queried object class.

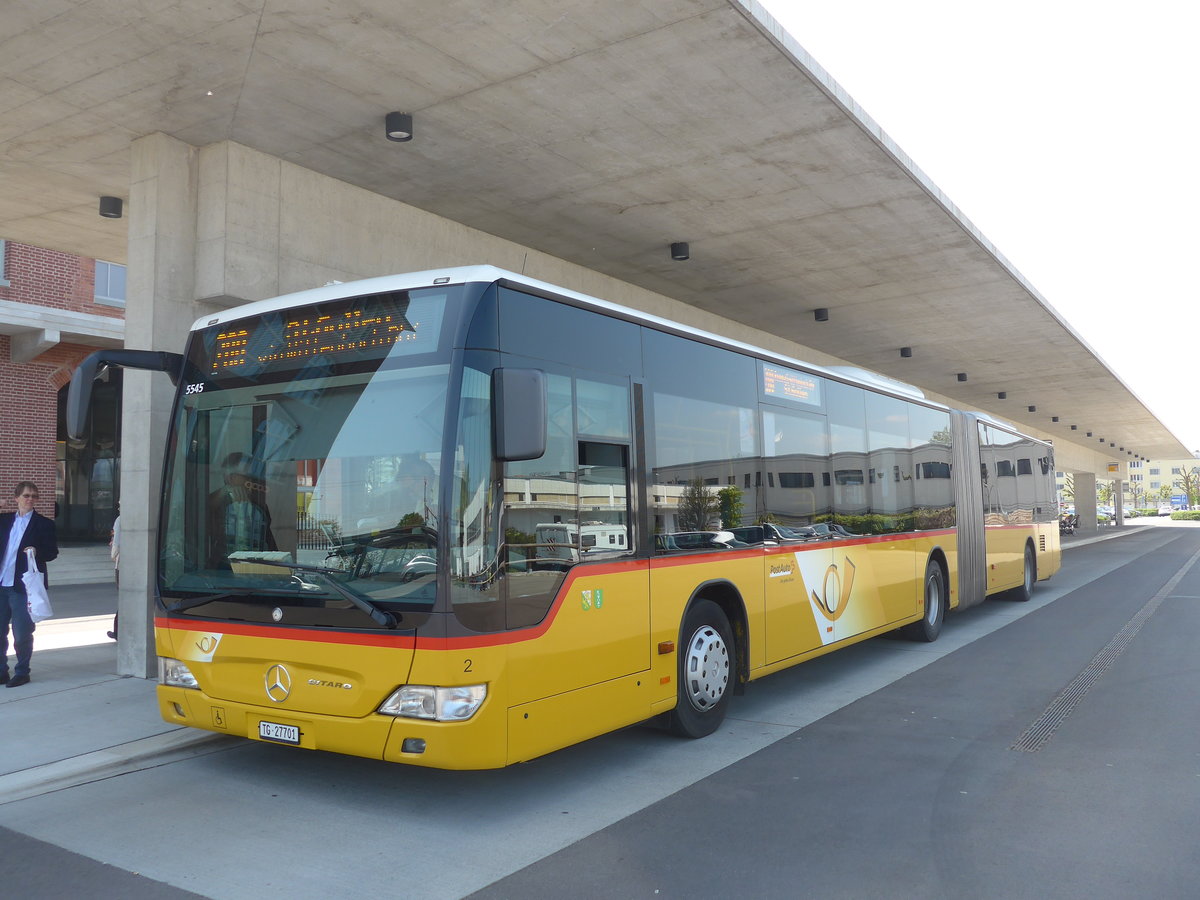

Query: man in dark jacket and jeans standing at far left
[0,481,59,688]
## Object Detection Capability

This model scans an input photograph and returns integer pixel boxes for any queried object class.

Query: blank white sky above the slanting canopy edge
[760,0,1200,450]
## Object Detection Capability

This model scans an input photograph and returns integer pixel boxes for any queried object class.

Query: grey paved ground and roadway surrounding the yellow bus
[0,522,1200,898]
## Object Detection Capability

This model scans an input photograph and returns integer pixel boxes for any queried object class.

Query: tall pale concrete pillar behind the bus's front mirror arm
[116,134,197,678]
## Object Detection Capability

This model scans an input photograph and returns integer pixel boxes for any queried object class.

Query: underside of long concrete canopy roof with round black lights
[0,0,1188,460]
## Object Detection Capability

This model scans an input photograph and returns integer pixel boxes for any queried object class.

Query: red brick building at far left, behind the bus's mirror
[0,240,125,541]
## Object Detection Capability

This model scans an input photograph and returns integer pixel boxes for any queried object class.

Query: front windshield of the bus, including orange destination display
[160,288,455,628]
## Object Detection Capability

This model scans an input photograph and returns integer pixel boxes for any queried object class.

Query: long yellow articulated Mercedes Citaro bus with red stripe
[68,266,1060,769]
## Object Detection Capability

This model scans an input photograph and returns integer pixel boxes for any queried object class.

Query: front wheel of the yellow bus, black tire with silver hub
[671,600,738,738]
